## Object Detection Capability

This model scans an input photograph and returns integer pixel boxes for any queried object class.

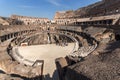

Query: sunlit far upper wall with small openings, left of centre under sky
[11,15,50,25]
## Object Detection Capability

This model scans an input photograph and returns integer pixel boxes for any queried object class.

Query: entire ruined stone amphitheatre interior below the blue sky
[0,0,120,80]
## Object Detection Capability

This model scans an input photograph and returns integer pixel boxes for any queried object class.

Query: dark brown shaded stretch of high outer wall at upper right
[75,0,120,17]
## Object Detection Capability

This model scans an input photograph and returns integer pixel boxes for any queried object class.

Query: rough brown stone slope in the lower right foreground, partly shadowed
[66,42,120,80]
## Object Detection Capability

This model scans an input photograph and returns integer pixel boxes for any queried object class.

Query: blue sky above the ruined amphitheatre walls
[0,0,100,19]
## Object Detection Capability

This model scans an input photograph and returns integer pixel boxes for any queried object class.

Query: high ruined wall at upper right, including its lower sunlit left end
[55,0,120,19]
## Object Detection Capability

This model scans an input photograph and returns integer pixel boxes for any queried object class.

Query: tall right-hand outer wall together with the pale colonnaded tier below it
[54,0,120,25]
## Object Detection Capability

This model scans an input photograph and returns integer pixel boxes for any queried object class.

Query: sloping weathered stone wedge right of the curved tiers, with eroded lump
[83,26,115,43]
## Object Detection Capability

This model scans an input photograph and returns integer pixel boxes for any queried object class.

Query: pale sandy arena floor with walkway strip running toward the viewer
[18,43,75,80]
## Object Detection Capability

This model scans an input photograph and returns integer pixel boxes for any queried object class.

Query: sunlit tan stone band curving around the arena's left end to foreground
[0,27,44,78]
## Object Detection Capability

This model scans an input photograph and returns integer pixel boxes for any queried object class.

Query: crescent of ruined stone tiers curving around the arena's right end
[56,28,98,57]
